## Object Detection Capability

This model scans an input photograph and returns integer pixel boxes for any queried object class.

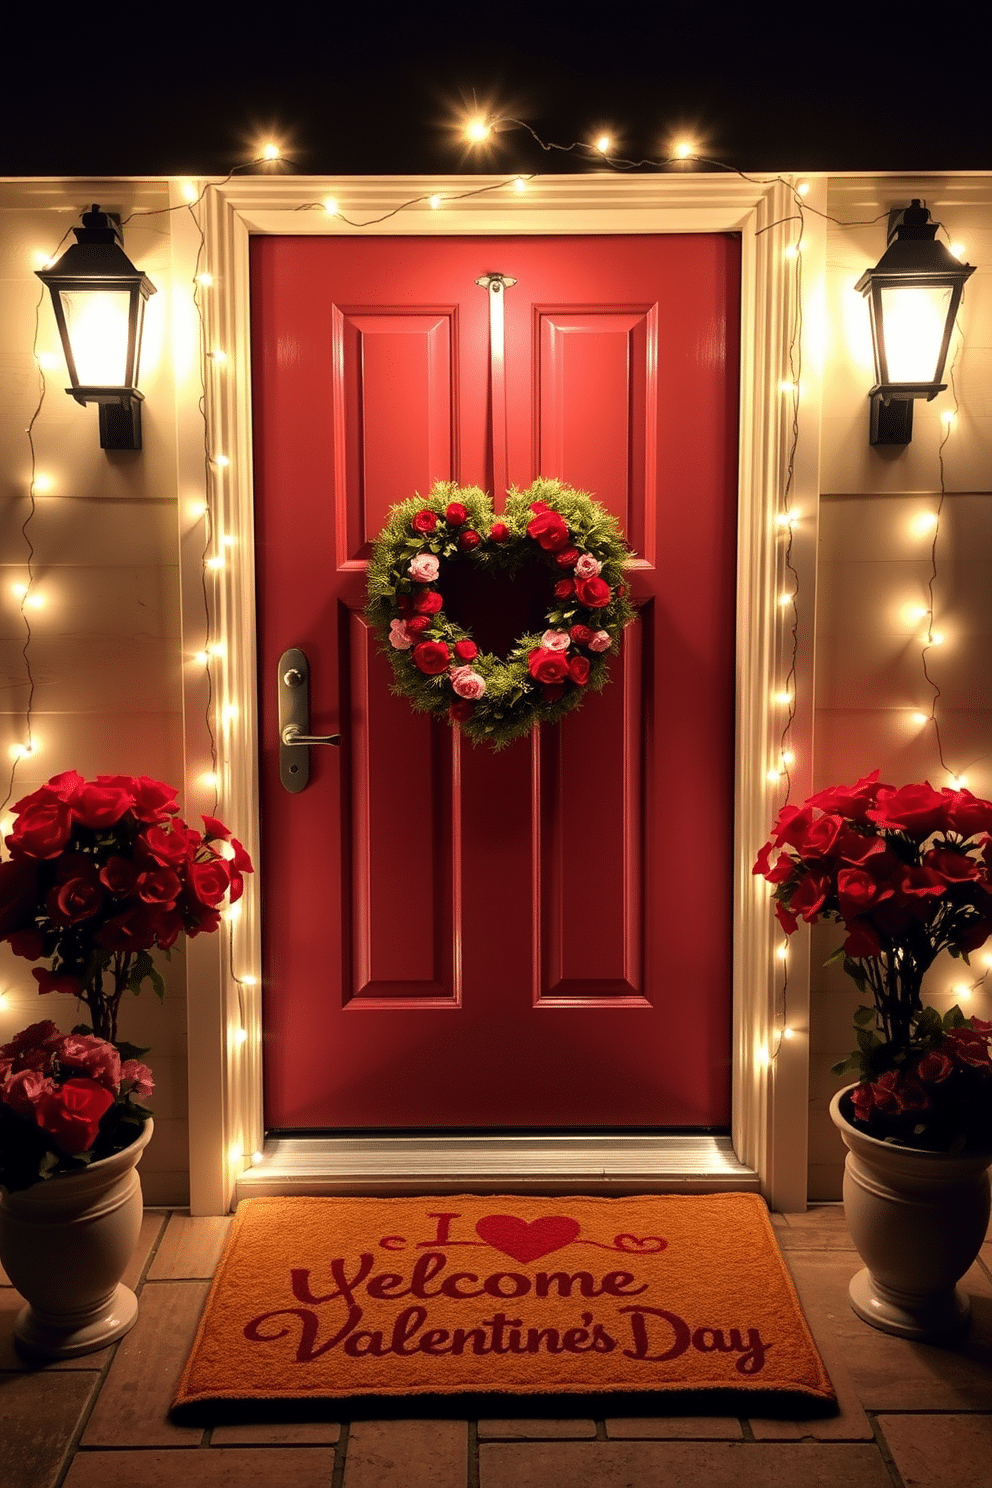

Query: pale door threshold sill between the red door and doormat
[235,1134,760,1202]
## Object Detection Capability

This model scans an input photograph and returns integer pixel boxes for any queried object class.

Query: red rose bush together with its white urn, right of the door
[754,771,992,1338]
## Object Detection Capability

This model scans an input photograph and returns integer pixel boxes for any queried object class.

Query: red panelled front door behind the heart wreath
[251,237,739,1129]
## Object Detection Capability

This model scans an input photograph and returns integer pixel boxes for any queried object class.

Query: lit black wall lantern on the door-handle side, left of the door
[37,204,155,449]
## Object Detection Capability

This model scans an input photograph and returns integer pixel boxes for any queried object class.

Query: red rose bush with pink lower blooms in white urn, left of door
[0,771,251,1357]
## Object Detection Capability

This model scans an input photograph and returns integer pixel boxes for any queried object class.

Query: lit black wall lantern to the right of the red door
[855,199,974,445]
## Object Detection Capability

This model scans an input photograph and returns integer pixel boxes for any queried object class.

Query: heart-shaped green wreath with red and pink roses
[366,481,634,748]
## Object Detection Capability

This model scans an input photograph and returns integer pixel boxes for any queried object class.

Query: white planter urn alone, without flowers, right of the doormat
[830,1085,992,1339]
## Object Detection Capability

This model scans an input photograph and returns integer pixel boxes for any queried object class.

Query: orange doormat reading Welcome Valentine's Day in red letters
[174,1193,834,1414]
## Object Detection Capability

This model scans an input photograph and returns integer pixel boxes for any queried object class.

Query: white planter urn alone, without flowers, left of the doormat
[0,1117,153,1359]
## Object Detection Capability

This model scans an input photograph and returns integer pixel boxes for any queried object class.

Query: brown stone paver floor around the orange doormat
[0,1205,992,1488]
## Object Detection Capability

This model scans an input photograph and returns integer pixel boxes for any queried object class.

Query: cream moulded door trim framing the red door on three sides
[171,174,825,1214]
